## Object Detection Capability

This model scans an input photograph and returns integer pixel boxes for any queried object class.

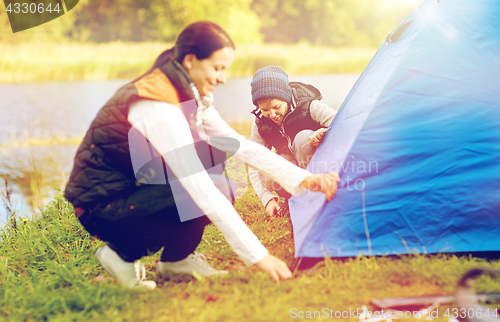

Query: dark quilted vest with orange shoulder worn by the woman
[65,62,226,209]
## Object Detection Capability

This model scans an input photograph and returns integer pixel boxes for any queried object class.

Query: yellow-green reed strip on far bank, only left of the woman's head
[0,42,170,82]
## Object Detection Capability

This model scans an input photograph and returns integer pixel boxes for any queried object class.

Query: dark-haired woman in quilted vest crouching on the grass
[65,22,339,289]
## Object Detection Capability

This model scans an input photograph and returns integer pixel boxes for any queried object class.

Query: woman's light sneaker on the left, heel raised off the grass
[96,245,156,290]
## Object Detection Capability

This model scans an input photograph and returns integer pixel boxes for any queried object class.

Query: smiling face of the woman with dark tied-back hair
[182,47,234,96]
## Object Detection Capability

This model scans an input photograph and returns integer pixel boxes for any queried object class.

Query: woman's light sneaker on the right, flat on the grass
[156,253,228,276]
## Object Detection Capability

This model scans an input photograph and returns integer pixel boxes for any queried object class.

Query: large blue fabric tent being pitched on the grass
[290,0,500,257]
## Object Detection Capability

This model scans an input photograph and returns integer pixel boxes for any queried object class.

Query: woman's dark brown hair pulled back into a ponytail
[150,21,236,71]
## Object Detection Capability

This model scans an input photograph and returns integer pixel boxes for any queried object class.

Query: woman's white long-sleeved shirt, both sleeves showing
[128,100,311,265]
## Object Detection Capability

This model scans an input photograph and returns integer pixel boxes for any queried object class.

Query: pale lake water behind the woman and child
[0,74,359,222]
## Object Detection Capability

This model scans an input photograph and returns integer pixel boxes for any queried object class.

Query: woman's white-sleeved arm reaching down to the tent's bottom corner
[128,100,268,264]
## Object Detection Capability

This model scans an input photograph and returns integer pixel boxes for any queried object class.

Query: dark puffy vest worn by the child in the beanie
[252,82,324,156]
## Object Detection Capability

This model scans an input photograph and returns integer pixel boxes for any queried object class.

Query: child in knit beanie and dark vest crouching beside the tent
[248,66,336,216]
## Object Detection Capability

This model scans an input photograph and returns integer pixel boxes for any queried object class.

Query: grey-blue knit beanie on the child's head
[250,66,292,106]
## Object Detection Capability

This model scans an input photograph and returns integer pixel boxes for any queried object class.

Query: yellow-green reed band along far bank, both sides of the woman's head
[0,42,375,83]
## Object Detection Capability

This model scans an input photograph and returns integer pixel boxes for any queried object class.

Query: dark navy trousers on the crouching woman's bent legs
[80,175,234,262]
